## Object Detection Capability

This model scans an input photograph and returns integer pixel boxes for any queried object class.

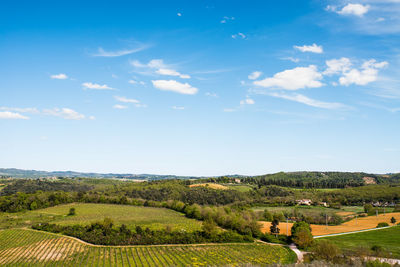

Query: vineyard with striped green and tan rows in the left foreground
[0,229,296,267]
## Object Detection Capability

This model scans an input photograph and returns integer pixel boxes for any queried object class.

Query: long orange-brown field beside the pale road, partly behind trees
[261,212,400,236]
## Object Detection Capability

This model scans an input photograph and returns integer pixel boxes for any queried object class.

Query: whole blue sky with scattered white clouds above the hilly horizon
[0,0,400,175]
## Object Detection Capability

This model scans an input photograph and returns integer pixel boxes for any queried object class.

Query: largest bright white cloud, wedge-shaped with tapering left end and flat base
[253,65,324,90]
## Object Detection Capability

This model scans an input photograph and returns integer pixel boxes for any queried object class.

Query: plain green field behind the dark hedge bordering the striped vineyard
[0,203,202,231]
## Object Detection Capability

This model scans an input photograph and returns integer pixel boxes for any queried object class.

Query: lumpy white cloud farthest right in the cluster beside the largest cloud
[339,59,388,86]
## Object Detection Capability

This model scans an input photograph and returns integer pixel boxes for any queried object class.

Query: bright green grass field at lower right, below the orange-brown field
[320,226,400,259]
